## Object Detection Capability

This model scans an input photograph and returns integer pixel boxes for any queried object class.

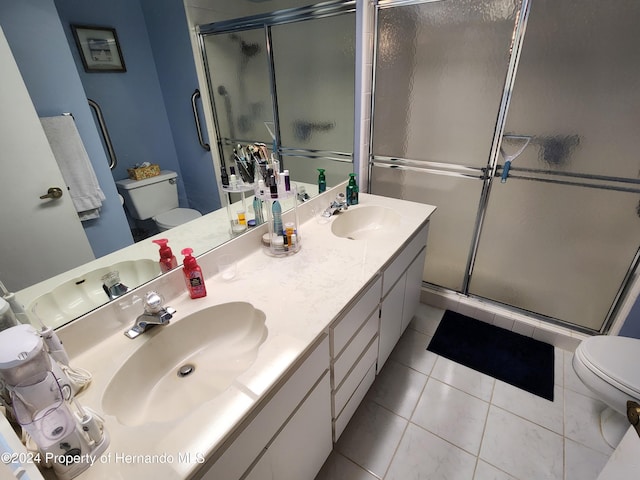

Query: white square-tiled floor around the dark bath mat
[316,304,612,480]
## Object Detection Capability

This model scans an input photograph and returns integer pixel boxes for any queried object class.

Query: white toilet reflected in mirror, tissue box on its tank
[116,170,202,232]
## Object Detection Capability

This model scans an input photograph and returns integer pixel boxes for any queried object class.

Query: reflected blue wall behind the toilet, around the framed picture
[55,0,188,206]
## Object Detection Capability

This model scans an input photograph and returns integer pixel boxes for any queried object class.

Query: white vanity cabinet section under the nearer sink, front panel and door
[195,334,332,480]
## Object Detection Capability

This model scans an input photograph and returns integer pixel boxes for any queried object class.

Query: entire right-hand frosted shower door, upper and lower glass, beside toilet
[469,0,640,331]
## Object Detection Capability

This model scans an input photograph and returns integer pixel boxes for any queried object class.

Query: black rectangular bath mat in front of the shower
[427,310,554,401]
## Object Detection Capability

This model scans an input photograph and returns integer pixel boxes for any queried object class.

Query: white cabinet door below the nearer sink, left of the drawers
[245,374,333,480]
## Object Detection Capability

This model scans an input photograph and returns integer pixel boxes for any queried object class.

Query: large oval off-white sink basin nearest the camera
[102,302,267,426]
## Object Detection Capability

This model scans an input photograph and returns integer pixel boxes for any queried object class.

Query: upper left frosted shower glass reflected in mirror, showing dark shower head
[204,28,274,144]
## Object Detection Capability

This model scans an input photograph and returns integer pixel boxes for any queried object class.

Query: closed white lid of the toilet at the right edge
[578,335,640,395]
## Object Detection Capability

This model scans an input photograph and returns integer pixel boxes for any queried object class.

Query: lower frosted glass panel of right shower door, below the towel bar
[469,179,640,331]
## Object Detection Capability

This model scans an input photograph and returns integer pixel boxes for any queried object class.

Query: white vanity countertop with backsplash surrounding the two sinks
[53,186,435,480]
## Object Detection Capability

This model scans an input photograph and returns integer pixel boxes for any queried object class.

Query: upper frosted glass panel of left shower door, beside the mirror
[373,0,521,167]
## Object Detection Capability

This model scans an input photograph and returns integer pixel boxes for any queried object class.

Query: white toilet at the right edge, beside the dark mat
[573,335,640,448]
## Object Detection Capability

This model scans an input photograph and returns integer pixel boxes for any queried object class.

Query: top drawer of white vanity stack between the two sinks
[329,277,382,358]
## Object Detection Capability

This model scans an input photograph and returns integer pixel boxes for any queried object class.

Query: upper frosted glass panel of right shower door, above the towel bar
[498,0,640,179]
